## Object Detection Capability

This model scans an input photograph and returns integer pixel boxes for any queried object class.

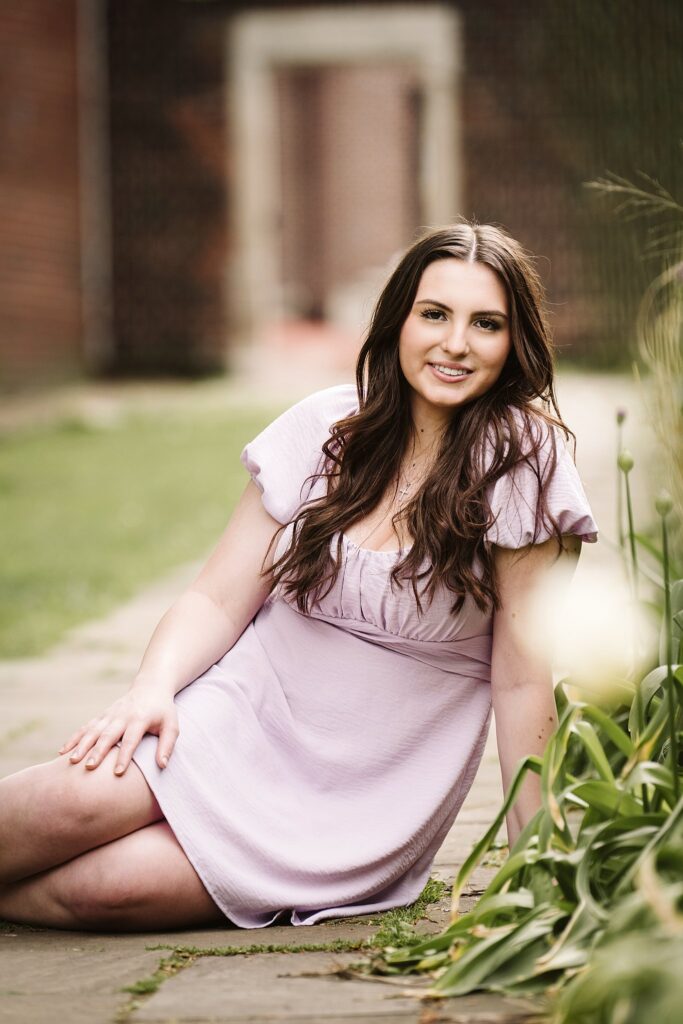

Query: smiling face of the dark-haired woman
[398,258,510,421]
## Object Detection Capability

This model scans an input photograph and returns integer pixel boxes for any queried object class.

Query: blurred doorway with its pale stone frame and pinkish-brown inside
[228,3,461,376]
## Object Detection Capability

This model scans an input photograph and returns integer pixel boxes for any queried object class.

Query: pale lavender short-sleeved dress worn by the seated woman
[129,385,597,928]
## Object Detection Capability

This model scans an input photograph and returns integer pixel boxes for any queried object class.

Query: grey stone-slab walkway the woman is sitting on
[0,377,651,1024]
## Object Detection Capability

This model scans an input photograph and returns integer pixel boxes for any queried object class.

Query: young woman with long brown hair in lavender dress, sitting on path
[0,223,596,930]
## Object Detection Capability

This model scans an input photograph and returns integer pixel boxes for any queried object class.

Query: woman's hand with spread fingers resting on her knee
[59,683,178,775]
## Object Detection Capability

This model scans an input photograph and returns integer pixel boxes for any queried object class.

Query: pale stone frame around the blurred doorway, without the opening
[226,3,462,348]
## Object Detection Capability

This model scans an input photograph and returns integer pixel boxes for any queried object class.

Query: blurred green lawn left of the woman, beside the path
[0,409,276,658]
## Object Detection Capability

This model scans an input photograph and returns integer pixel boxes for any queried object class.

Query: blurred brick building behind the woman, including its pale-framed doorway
[0,0,683,388]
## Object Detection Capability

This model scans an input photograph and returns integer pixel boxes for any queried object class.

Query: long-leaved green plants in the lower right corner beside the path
[365,483,683,1024]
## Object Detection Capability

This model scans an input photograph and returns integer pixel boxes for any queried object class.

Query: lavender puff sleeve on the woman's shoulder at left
[240,384,358,524]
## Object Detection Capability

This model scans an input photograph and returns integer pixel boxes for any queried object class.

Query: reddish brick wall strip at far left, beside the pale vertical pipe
[0,0,81,388]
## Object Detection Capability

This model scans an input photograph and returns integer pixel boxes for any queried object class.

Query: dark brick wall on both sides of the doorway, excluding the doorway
[0,0,683,386]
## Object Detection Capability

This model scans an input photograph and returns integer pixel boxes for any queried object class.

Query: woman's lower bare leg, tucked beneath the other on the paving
[0,821,227,932]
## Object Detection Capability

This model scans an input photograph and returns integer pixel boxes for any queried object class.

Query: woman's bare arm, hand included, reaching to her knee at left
[59,481,280,775]
